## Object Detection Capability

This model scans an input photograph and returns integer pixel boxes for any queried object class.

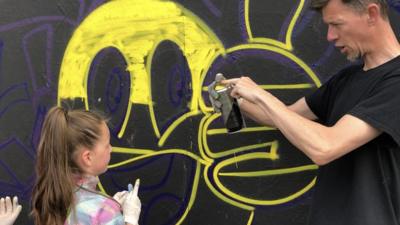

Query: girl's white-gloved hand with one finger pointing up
[122,179,142,225]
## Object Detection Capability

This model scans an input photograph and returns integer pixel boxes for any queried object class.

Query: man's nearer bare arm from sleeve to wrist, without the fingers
[260,92,381,165]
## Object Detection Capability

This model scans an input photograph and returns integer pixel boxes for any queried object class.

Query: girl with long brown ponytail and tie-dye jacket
[32,107,141,225]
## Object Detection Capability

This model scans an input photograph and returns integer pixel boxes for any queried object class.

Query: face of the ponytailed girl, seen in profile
[91,123,111,176]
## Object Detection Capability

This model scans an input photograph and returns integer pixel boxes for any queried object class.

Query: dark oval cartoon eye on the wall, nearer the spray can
[150,41,193,133]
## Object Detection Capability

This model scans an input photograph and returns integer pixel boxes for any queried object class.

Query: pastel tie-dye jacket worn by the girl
[65,176,125,225]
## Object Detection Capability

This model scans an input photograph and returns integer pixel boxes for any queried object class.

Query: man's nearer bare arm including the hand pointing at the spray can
[226,77,381,165]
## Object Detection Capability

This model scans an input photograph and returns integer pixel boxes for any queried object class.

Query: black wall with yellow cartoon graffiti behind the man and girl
[0,0,400,225]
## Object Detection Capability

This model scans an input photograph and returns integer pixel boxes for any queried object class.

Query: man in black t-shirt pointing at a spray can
[222,0,400,225]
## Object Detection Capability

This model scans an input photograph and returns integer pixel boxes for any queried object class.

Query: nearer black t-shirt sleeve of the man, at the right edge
[349,75,400,145]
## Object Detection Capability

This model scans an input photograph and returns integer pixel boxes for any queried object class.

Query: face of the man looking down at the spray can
[322,0,368,61]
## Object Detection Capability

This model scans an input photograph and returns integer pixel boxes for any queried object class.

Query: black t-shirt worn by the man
[306,57,400,225]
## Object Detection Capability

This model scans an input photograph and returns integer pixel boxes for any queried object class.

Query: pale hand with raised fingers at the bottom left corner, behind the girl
[0,196,22,225]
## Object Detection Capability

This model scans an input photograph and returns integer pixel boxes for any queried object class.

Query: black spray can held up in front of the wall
[208,73,246,133]
